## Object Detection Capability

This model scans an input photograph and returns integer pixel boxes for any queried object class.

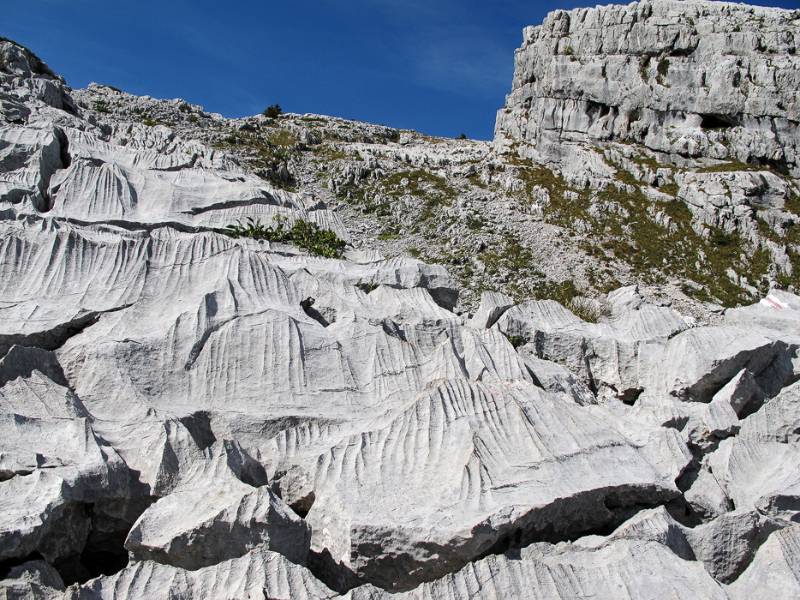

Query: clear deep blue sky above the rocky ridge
[7,0,800,139]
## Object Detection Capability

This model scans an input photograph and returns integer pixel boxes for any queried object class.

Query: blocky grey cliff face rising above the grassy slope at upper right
[496,0,800,177]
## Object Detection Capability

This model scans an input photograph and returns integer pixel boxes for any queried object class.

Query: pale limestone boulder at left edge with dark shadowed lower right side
[0,346,131,562]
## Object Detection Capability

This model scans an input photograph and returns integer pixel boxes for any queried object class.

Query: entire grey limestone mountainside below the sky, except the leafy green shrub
[0,0,800,600]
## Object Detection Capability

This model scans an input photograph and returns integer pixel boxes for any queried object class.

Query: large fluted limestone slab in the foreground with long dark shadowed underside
[307,382,690,590]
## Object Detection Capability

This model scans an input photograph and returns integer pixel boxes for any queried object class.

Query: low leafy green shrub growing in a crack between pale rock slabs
[222,217,347,258]
